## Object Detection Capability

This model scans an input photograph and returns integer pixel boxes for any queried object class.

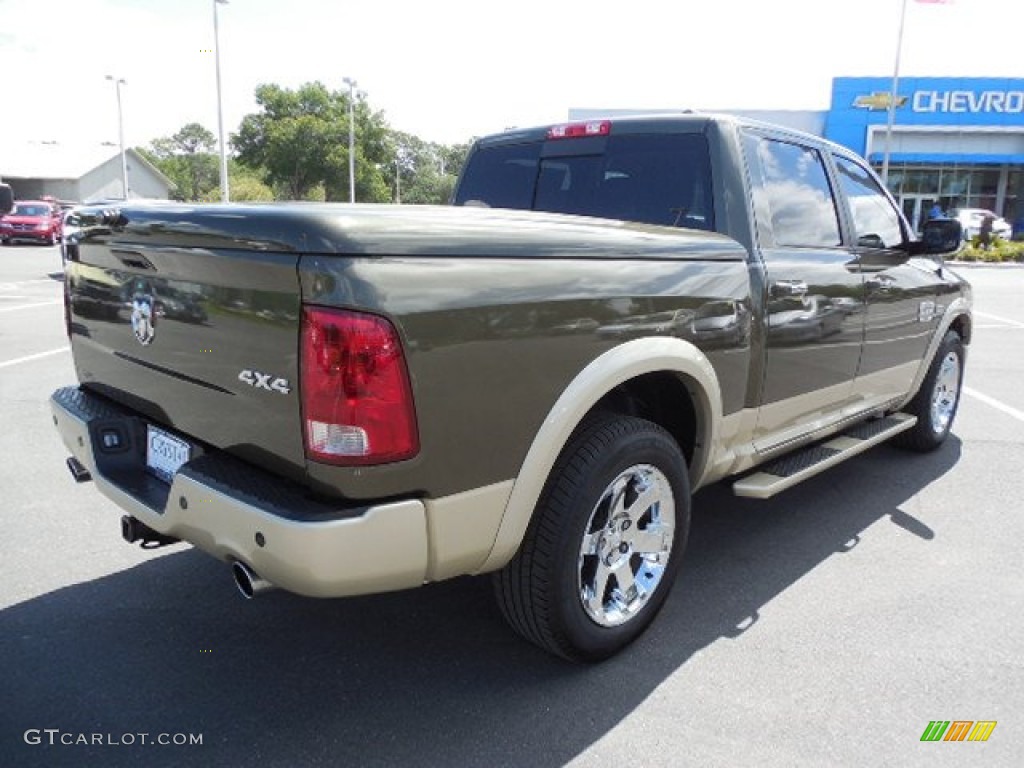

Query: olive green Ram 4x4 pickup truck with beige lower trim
[51,115,971,660]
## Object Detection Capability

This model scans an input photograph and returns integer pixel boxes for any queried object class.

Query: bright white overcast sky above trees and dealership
[0,0,1024,153]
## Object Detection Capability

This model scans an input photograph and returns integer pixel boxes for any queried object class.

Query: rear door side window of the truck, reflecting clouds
[755,137,841,248]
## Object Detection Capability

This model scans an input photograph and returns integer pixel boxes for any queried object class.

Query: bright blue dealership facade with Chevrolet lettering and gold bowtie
[825,78,1024,164]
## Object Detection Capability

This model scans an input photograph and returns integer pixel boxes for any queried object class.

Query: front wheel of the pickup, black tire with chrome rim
[893,331,966,453]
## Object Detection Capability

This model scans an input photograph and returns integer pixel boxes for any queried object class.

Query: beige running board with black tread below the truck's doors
[732,414,918,499]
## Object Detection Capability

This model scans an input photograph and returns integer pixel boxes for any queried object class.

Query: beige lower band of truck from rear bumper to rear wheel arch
[51,391,513,597]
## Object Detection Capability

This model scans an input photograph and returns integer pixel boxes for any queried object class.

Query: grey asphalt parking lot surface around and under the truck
[0,247,1024,767]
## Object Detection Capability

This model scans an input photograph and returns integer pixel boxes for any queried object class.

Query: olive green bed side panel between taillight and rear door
[300,253,751,499]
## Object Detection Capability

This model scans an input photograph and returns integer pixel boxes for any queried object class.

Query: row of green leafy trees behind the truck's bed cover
[146,82,470,205]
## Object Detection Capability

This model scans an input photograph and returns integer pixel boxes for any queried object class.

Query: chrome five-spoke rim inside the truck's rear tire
[578,464,676,627]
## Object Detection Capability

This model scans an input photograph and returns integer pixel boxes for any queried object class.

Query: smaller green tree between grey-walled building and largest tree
[141,123,220,201]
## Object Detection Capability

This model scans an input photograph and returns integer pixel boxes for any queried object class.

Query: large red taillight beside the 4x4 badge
[301,307,420,464]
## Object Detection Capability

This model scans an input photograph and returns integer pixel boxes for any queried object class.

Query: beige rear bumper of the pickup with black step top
[50,387,428,597]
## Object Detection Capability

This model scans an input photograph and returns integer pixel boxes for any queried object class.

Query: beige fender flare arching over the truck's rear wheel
[479,337,722,572]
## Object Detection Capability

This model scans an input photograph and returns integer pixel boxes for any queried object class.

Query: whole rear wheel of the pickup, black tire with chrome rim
[494,415,690,662]
